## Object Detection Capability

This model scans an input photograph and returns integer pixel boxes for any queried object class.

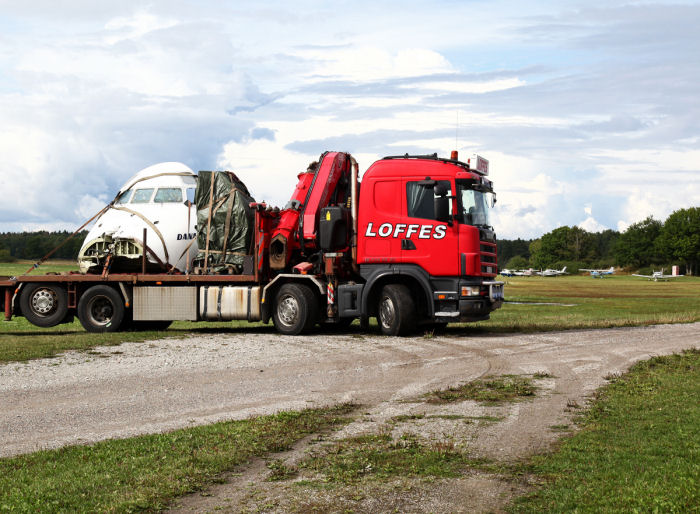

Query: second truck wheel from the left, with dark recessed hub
[78,285,124,332]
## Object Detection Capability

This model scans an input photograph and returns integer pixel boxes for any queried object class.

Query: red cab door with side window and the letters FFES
[395,179,459,276]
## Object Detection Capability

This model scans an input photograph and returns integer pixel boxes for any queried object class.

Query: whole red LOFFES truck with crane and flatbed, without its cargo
[0,152,503,335]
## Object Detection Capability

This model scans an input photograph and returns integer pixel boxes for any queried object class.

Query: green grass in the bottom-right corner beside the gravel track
[511,350,700,513]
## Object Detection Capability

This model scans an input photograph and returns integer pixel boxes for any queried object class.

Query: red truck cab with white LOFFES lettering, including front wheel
[356,153,503,333]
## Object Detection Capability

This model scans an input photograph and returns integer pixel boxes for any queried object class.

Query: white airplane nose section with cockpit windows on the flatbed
[78,162,198,273]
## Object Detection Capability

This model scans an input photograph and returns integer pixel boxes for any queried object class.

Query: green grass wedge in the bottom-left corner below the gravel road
[0,405,354,512]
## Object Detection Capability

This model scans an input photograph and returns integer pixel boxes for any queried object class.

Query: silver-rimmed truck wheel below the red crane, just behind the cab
[272,284,318,335]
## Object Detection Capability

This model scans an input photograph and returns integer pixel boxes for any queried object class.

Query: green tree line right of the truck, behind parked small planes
[498,207,700,275]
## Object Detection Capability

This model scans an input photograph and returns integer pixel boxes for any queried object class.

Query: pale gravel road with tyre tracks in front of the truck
[0,323,700,510]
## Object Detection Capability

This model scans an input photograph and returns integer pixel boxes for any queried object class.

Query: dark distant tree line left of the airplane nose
[0,230,87,262]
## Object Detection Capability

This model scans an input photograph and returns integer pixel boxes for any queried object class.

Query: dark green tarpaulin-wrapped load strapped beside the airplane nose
[194,171,255,274]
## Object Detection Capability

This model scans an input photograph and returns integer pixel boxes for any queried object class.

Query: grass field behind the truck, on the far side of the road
[0,261,700,362]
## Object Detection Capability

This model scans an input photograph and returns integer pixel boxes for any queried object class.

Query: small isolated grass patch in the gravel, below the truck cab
[425,375,537,405]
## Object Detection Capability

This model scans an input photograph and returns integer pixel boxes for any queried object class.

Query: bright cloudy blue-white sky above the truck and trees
[0,0,700,239]
